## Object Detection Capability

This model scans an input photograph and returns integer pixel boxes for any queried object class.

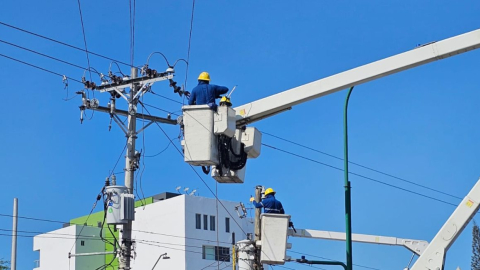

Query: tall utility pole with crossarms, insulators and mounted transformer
[74,62,185,270]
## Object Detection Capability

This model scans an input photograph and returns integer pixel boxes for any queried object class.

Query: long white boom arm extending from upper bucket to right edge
[235,29,480,126]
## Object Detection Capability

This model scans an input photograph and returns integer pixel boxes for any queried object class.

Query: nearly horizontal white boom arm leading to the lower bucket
[288,229,428,256]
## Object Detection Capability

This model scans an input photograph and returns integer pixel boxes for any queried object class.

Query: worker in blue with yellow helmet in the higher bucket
[188,71,228,111]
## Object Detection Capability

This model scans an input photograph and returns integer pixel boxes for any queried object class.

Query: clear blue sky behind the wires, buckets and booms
[0,0,480,270]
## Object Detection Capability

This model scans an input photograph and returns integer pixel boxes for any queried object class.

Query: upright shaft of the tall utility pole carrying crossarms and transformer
[119,67,138,270]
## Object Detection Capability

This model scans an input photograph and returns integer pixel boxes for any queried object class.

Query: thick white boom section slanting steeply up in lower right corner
[411,179,480,270]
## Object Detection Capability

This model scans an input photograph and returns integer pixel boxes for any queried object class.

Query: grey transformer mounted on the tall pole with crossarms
[105,186,135,224]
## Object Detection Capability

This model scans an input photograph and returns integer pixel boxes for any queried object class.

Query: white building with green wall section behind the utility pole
[34,193,253,270]
